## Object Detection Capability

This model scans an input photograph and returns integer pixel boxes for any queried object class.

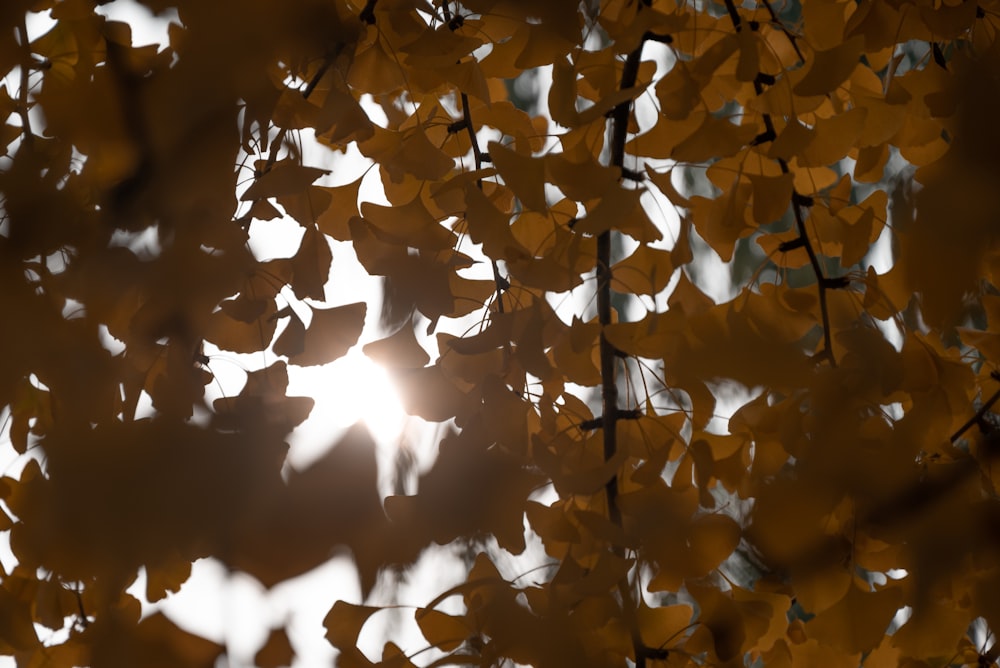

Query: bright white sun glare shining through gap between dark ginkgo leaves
[288,348,409,466]
